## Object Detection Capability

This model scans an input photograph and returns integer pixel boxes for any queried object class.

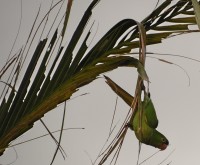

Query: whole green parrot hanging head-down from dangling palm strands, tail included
[105,76,169,150]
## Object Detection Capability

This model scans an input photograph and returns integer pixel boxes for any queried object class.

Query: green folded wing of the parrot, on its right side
[143,93,158,129]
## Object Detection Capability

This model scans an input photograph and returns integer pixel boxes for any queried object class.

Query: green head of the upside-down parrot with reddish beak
[149,130,169,150]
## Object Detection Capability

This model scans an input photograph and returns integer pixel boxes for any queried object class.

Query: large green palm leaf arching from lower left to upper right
[0,0,199,154]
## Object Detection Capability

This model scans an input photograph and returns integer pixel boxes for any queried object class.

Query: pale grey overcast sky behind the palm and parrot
[0,0,200,165]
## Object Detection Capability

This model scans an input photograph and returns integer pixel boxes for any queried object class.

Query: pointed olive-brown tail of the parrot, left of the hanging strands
[104,76,134,107]
